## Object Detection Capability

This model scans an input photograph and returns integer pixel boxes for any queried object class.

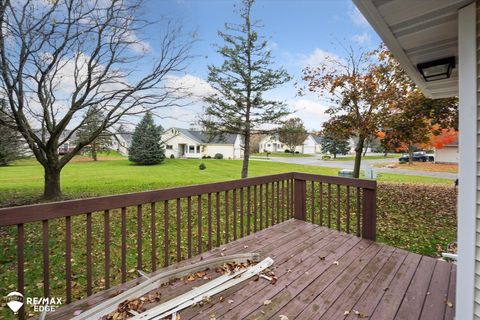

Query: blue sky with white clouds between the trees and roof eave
[137,0,380,130]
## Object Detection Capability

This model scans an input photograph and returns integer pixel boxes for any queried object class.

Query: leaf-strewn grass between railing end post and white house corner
[377,183,457,257]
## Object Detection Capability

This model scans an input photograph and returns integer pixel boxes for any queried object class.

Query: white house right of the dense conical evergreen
[162,128,243,159]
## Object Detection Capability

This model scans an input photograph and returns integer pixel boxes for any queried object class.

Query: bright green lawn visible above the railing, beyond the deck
[0,159,452,206]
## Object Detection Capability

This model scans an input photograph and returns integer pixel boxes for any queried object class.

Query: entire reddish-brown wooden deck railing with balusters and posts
[0,173,376,319]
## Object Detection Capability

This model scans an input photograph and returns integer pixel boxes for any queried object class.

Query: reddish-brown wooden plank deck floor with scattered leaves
[48,220,456,320]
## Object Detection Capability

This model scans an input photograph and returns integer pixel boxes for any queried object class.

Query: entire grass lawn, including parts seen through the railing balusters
[0,157,456,319]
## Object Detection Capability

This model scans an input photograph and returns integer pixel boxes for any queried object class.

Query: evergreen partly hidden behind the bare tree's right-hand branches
[76,107,112,161]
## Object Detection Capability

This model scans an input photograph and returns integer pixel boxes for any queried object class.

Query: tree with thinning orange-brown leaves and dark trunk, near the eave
[300,46,413,178]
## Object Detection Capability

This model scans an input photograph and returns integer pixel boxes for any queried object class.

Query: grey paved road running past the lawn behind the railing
[252,156,457,180]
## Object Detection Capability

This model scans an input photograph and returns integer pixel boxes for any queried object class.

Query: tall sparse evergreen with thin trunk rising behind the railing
[201,0,290,178]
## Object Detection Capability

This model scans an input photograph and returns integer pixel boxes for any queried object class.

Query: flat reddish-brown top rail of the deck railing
[0,172,376,227]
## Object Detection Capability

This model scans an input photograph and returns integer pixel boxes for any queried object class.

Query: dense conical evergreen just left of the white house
[128,112,165,165]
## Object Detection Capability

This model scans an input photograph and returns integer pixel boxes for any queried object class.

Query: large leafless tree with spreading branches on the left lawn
[0,0,191,199]
